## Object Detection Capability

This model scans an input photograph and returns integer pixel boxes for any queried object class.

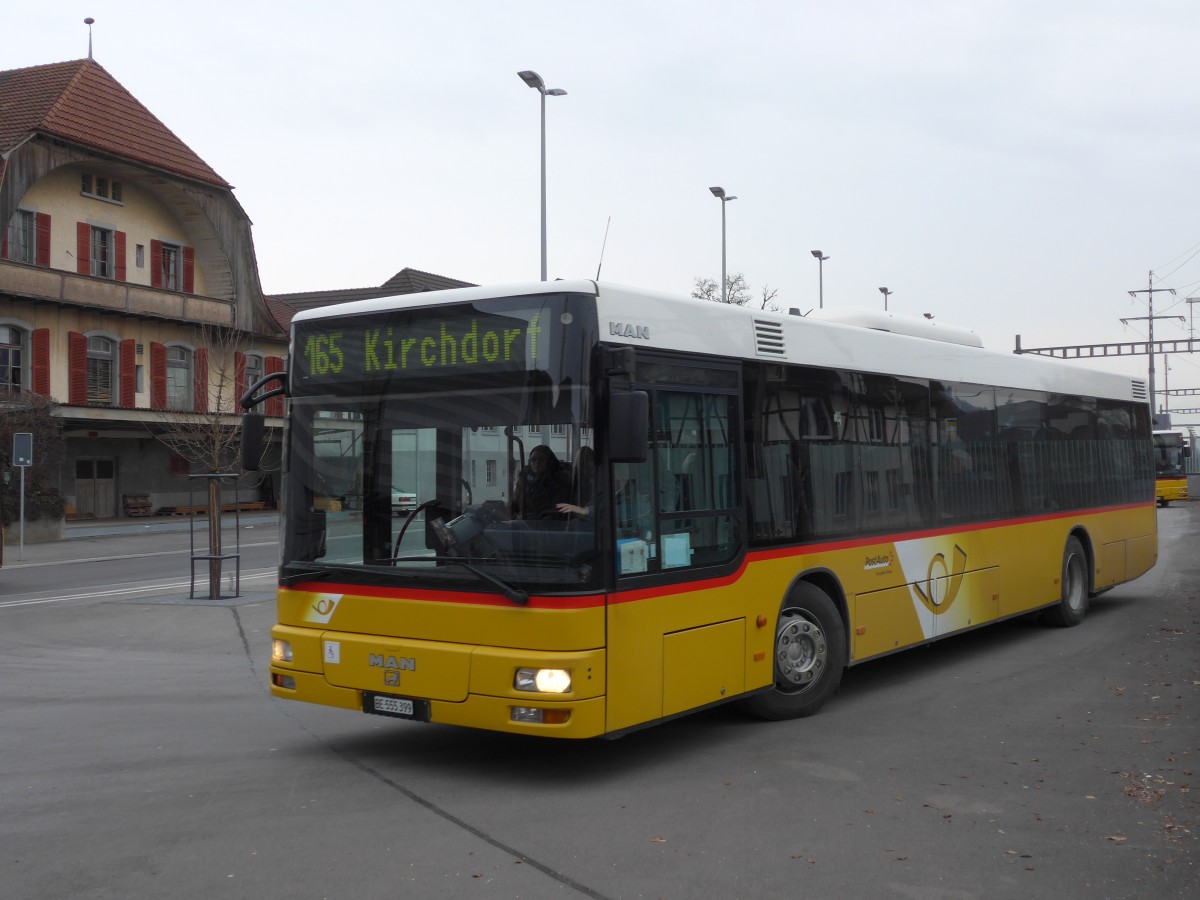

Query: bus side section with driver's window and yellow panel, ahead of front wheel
[607,355,746,730]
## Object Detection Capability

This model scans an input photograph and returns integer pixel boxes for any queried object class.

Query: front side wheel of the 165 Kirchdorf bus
[744,582,846,720]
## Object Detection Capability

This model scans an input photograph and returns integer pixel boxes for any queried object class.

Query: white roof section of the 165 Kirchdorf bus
[293,280,1147,402]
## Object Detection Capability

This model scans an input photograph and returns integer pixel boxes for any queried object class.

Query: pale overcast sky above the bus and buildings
[9,0,1200,408]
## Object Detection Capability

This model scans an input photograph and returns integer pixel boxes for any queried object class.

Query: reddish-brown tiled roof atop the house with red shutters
[0,59,232,188]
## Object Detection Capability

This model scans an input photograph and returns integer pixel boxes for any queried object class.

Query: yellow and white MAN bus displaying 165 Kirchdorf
[242,281,1157,738]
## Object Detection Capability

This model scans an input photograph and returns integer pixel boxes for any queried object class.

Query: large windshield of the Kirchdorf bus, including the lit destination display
[282,295,596,600]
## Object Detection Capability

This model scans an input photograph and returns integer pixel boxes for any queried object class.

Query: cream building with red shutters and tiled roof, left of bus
[0,59,287,518]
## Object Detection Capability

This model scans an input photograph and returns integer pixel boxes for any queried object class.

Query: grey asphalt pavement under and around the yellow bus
[0,504,1200,900]
